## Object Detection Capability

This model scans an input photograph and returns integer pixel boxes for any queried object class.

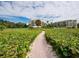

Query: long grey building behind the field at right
[53,20,77,28]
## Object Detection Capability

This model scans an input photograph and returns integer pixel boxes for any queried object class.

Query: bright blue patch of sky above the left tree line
[0,15,31,23]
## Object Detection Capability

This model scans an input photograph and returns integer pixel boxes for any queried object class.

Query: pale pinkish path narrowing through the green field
[28,31,57,58]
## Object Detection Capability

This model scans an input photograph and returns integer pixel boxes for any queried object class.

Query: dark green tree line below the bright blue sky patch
[0,19,28,28]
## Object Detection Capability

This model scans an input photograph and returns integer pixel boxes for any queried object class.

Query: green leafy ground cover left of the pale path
[0,29,41,58]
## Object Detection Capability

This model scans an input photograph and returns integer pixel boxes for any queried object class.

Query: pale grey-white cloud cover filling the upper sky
[0,1,79,22]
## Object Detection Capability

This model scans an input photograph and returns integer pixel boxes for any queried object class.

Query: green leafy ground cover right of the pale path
[46,28,79,58]
